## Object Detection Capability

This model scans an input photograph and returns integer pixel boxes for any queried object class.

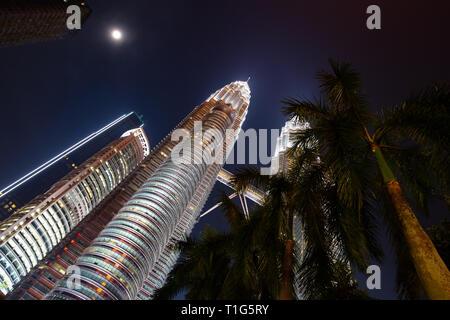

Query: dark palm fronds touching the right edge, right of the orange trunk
[374,84,450,211]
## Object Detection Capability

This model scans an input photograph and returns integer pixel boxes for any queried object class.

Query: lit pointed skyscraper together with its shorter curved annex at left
[0,81,250,300]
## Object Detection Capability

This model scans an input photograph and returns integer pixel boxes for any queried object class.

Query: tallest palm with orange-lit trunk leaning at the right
[283,59,450,299]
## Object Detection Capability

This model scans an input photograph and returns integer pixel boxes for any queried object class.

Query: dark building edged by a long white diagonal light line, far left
[0,112,144,221]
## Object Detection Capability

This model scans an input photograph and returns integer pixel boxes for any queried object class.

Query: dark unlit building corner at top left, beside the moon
[0,0,91,46]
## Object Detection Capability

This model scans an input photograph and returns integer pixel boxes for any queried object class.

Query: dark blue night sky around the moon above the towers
[0,0,450,299]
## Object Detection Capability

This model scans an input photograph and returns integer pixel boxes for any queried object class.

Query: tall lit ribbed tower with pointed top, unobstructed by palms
[45,81,250,299]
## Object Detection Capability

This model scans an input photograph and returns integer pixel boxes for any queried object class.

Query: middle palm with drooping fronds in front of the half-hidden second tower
[233,144,382,300]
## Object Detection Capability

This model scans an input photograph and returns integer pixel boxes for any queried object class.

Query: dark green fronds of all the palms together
[157,59,450,299]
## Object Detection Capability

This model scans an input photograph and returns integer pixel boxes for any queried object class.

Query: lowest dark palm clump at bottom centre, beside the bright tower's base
[154,194,279,300]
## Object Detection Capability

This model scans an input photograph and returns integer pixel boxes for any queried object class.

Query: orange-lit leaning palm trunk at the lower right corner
[372,146,450,300]
